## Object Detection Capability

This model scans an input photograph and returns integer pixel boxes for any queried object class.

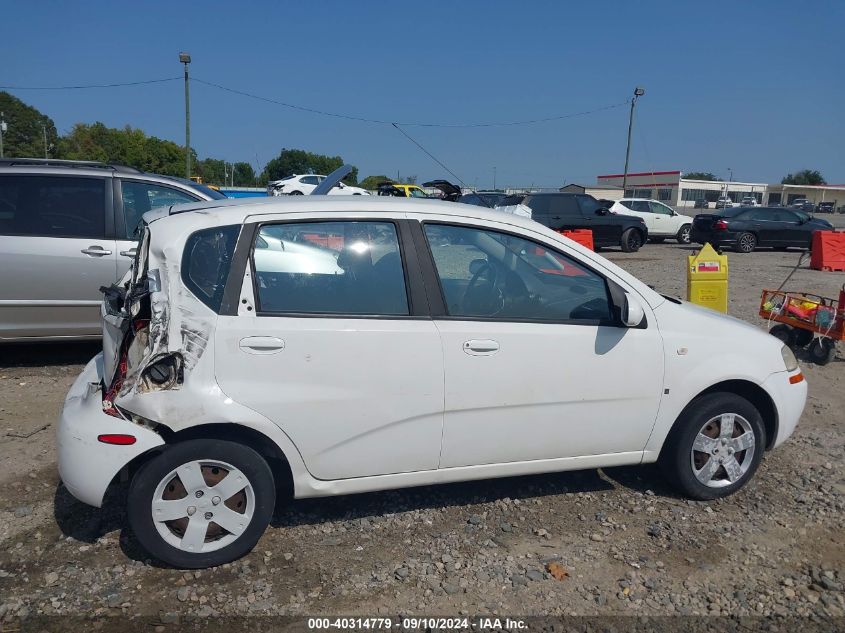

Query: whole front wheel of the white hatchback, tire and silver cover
[660,393,766,500]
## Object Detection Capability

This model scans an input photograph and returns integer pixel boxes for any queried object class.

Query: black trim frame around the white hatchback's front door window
[418,220,628,329]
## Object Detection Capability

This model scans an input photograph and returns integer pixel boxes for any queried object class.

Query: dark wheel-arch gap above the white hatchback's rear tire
[158,422,293,503]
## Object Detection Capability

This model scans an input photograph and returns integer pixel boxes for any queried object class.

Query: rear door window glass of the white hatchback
[253,221,410,316]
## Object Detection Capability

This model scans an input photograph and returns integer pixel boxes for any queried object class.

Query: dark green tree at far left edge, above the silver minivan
[0,91,59,158]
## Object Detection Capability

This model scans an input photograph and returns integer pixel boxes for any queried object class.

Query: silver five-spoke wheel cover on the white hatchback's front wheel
[690,413,757,488]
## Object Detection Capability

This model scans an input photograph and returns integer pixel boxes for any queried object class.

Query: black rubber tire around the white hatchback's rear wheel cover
[127,439,276,569]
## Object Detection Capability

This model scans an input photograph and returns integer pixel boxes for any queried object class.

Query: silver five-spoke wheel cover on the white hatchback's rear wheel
[150,459,255,554]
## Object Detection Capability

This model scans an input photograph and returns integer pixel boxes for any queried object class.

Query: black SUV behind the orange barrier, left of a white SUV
[499,193,648,253]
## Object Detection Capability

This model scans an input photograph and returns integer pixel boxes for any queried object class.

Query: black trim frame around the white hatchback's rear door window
[242,215,431,321]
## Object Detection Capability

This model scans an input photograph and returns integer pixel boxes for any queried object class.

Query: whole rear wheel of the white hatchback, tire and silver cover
[127,439,276,569]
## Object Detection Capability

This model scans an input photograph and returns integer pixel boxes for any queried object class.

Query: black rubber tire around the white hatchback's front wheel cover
[659,393,766,501]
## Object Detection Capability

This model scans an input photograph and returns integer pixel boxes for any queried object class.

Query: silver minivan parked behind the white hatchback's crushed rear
[0,158,225,342]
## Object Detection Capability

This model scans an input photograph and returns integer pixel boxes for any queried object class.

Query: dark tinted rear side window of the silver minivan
[0,174,106,239]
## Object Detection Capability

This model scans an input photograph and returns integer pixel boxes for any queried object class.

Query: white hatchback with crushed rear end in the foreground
[58,196,807,568]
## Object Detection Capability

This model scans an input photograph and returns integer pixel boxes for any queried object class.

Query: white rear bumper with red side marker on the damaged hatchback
[56,354,164,508]
